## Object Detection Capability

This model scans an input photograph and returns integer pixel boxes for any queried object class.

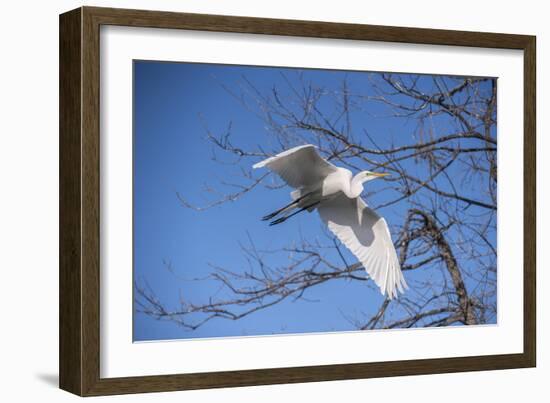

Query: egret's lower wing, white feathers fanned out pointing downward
[318,194,407,298]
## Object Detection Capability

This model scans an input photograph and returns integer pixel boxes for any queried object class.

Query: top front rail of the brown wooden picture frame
[85,7,528,49]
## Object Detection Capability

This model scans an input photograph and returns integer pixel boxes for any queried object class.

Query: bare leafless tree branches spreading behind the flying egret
[135,73,497,330]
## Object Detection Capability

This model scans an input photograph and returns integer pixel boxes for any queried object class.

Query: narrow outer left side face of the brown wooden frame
[59,10,83,394]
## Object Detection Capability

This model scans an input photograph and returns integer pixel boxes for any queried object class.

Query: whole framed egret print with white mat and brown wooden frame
[60,7,536,396]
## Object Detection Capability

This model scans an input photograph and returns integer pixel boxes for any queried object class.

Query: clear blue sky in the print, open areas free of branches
[134,61,496,341]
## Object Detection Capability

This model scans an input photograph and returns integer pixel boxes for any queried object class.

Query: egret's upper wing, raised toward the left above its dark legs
[253,144,337,188]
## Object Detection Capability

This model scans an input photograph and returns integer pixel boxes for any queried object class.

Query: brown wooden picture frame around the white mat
[59,7,536,396]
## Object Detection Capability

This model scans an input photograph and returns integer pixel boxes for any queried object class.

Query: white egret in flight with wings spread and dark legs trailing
[253,144,407,298]
